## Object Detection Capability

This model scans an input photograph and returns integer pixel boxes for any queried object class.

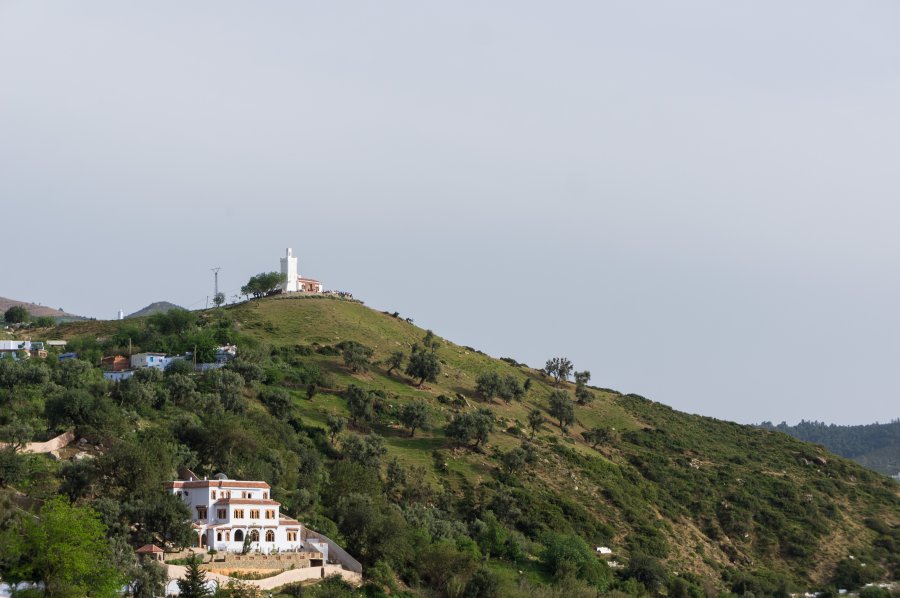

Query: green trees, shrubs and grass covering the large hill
[0,296,900,596]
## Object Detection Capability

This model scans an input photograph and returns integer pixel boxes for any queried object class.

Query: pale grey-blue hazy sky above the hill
[0,0,900,424]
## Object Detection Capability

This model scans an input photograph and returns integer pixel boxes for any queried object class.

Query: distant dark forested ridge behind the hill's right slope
[759,419,900,475]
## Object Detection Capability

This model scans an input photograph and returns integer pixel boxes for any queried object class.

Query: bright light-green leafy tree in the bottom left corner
[0,497,125,597]
